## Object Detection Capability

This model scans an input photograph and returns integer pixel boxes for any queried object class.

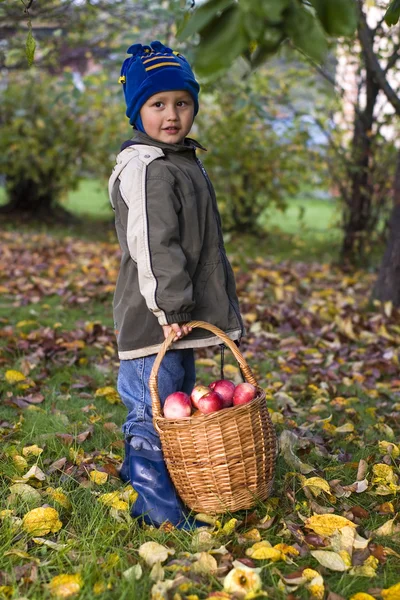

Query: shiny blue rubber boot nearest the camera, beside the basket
[129,447,209,530]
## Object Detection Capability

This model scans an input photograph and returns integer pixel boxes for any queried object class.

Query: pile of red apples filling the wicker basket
[164,379,257,419]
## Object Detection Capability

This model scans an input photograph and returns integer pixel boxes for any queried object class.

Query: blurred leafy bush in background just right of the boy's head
[196,66,324,233]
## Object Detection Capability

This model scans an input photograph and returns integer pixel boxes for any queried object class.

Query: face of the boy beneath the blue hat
[140,90,194,144]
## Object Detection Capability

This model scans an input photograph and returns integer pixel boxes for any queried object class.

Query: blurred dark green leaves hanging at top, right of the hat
[179,0,357,75]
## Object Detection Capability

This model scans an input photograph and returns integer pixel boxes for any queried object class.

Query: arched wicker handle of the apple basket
[149,321,257,421]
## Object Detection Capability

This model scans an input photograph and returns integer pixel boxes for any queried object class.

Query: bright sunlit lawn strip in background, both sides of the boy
[0,179,341,261]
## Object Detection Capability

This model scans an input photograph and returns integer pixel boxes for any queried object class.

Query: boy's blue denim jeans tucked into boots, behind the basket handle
[118,348,196,448]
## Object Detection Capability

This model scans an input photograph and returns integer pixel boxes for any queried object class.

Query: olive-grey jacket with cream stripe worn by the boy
[109,132,243,360]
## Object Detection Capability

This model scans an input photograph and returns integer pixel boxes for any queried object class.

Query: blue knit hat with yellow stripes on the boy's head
[119,41,200,131]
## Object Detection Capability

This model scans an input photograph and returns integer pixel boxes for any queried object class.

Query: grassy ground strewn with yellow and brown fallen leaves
[0,232,400,600]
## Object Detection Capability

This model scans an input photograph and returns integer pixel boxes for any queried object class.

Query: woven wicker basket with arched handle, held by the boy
[149,321,277,514]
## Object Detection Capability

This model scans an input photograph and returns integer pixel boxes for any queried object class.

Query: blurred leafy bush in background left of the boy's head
[0,70,127,212]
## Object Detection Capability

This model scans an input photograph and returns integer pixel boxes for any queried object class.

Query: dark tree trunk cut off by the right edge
[372,150,400,307]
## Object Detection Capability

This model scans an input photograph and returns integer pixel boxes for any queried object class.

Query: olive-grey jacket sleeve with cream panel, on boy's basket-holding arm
[123,171,195,325]
